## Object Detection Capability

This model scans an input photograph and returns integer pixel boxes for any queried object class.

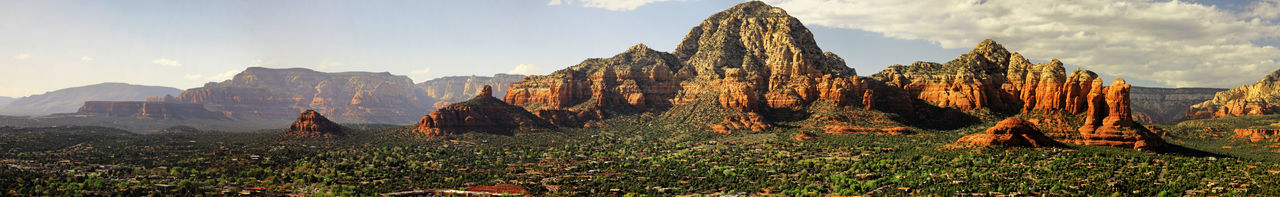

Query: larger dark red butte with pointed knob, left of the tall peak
[413,86,552,137]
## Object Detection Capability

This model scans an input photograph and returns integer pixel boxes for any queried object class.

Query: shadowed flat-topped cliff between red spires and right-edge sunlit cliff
[1129,87,1226,124]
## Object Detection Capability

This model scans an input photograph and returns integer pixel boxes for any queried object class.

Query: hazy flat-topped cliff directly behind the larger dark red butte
[415,74,525,109]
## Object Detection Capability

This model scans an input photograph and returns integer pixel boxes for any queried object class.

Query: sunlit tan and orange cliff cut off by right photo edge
[1187,70,1280,119]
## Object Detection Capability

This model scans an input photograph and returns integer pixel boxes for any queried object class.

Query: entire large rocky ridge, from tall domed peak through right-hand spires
[494,1,1164,148]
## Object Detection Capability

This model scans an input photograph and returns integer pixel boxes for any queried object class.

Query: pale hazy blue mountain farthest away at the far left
[0,83,182,115]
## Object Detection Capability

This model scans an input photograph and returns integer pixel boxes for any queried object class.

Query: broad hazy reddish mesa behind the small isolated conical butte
[168,68,430,123]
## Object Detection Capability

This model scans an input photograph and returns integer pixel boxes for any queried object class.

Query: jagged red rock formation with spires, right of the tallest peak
[872,40,1164,148]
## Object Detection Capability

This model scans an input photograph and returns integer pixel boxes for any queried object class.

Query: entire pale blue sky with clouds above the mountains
[0,0,1280,97]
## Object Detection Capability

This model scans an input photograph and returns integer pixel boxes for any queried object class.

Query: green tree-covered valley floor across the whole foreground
[0,115,1280,196]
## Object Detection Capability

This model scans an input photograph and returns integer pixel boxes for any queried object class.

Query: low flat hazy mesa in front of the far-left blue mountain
[77,101,227,120]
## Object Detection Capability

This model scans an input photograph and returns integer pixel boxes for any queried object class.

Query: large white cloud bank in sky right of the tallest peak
[767,0,1280,87]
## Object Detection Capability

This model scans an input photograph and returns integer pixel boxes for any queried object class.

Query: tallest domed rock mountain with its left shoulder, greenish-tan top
[504,3,865,129]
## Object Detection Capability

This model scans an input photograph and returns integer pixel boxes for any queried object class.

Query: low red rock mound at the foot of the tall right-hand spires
[956,118,1060,147]
